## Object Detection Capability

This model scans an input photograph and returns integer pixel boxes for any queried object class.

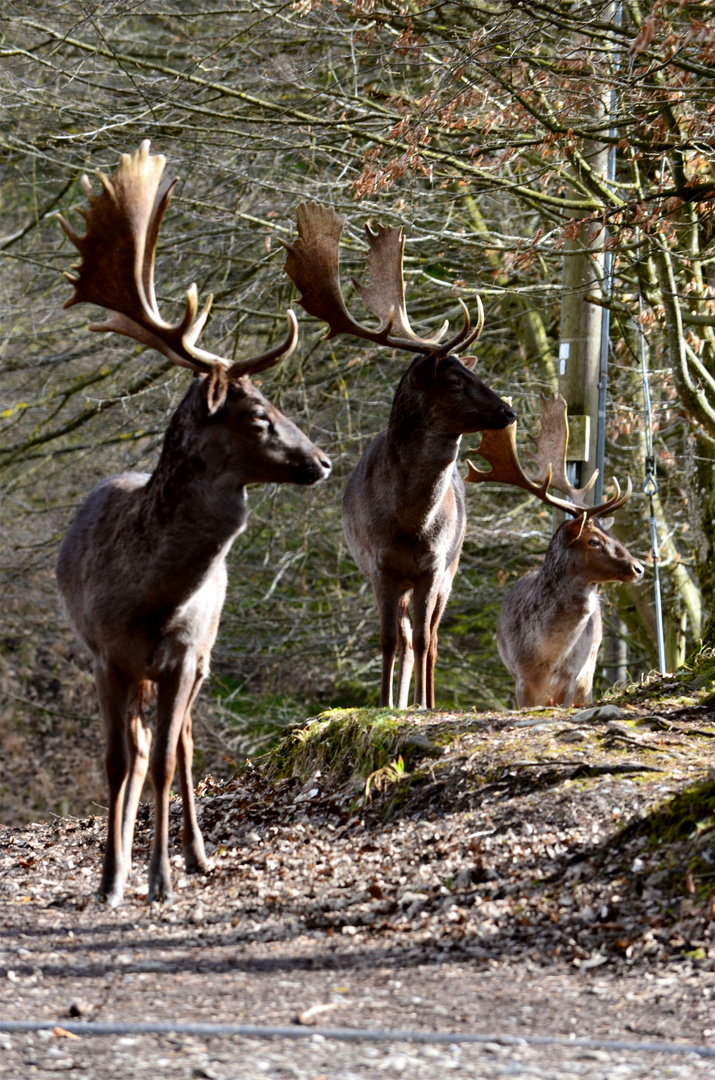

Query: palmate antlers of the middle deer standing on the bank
[281,203,484,355]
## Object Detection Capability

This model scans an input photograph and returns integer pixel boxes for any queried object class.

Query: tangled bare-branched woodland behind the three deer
[0,0,715,816]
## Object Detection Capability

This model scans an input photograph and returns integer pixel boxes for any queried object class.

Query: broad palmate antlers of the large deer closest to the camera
[59,139,298,379]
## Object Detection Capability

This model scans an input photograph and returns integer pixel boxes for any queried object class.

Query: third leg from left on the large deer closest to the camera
[147,659,195,903]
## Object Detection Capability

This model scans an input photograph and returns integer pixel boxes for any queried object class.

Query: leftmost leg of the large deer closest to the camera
[94,660,130,907]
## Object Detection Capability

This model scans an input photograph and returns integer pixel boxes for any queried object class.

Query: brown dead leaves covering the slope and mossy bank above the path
[0,686,715,984]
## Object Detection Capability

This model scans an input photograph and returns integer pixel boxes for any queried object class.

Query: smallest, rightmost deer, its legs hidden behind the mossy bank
[467,395,644,708]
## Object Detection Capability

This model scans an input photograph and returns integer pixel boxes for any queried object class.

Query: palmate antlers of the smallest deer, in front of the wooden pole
[464,394,633,522]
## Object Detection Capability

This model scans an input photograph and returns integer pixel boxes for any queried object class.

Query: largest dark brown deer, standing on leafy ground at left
[57,140,330,906]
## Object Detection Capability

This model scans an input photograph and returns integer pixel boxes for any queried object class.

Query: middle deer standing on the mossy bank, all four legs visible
[285,204,516,708]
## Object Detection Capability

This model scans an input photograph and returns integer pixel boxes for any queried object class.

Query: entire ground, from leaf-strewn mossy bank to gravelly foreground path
[0,696,715,1080]
